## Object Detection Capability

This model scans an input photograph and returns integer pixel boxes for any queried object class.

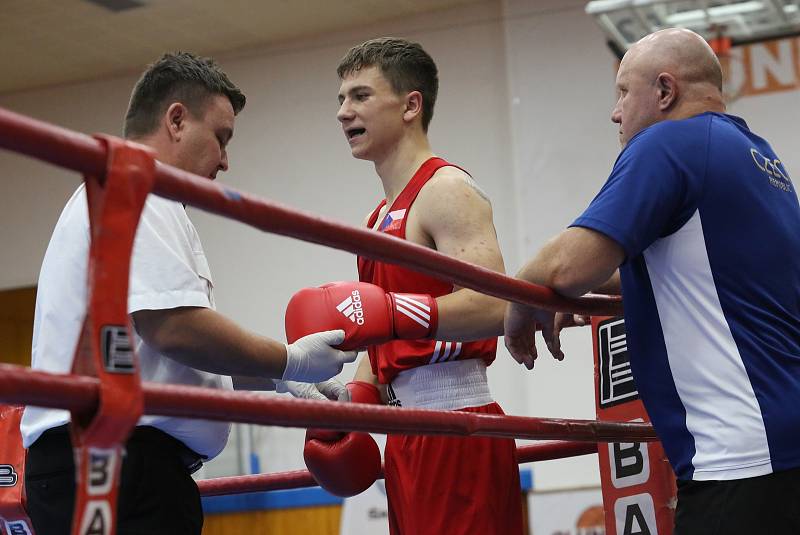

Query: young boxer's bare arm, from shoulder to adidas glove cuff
[414,167,506,341]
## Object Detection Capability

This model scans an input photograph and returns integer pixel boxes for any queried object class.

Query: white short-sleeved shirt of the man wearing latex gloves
[20,185,233,459]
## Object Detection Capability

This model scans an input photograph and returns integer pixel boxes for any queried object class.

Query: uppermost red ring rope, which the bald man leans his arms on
[0,108,622,315]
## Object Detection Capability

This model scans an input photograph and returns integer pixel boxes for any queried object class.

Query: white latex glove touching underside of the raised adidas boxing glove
[281,329,358,383]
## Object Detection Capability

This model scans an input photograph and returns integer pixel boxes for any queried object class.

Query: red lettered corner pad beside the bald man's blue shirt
[592,316,677,535]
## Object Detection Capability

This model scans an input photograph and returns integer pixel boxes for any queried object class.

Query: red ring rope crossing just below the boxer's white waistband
[0,364,656,442]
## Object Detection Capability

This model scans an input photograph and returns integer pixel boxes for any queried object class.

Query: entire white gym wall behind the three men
[0,0,800,488]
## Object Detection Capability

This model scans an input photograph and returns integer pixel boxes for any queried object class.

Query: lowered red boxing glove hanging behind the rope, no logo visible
[303,381,381,498]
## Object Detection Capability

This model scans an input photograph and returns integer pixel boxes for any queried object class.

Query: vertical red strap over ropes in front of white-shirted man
[70,135,155,535]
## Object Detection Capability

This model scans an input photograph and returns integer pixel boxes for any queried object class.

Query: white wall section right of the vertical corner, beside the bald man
[505,0,618,488]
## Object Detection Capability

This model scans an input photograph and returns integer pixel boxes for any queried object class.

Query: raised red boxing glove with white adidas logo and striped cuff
[286,282,439,350]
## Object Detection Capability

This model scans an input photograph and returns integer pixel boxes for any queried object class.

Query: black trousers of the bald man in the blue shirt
[673,468,800,535]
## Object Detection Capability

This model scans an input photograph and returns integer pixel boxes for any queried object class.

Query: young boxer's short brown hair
[336,37,439,132]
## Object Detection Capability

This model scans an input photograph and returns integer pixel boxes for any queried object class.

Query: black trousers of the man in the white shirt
[25,426,203,535]
